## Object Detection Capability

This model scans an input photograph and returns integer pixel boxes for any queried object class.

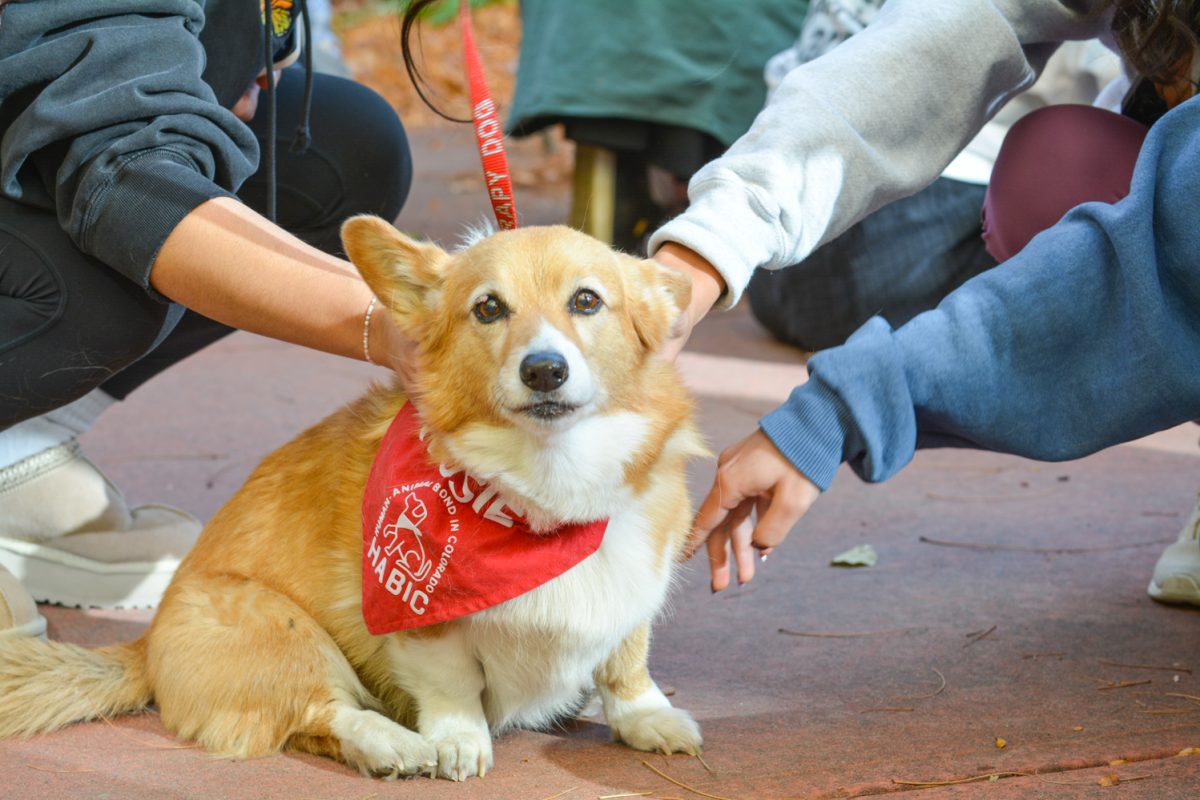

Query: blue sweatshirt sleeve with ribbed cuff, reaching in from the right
[761,97,1200,489]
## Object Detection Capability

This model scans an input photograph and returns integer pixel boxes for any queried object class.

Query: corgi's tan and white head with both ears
[342,217,690,433]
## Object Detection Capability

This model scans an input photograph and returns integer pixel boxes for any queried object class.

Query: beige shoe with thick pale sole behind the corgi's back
[0,441,202,608]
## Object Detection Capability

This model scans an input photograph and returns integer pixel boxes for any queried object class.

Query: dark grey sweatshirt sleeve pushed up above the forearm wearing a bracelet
[0,0,258,288]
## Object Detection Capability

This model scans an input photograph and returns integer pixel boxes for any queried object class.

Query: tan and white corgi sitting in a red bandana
[0,216,706,780]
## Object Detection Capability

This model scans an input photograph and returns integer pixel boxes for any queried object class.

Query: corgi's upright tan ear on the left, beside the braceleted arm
[342,213,449,323]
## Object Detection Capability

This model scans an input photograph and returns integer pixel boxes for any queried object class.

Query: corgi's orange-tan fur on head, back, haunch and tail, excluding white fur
[0,218,700,777]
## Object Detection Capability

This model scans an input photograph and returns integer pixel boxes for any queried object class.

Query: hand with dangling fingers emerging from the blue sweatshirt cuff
[689,429,821,593]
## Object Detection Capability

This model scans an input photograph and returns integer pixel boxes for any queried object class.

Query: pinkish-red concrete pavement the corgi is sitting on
[0,128,1200,800]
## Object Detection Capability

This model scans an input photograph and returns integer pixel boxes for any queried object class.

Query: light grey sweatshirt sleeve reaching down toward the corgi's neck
[650,0,1109,303]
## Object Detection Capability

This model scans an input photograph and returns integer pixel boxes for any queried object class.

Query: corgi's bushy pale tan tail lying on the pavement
[0,637,152,739]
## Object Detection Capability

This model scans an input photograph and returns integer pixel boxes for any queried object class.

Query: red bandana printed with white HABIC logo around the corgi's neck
[362,403,608,636]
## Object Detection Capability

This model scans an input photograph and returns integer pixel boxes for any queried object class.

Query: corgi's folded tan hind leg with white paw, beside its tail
[148,576,437,777]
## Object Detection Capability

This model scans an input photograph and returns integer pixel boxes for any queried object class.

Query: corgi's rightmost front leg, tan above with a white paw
[595,625,703,756]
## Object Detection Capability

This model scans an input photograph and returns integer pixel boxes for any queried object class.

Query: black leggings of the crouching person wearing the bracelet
[0,68,413,429]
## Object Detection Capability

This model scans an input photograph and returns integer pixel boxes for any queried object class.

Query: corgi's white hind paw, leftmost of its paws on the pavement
[334,709,438,780]
